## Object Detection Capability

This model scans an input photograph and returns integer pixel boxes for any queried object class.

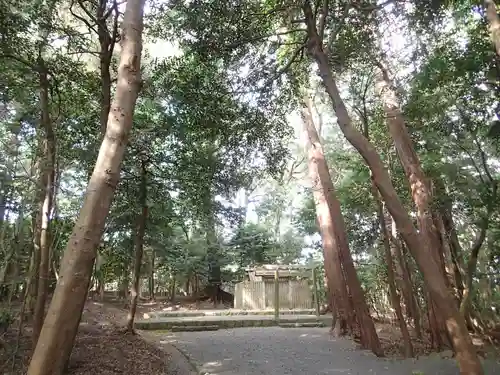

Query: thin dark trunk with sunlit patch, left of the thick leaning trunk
[32,68,56,344]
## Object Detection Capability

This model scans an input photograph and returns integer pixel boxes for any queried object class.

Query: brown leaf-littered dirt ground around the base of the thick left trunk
[0,300,171,375]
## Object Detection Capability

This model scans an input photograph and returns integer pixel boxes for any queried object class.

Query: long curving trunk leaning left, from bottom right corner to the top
[303,1,483,375]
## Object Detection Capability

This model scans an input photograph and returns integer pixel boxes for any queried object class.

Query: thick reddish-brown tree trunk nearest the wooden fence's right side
[302,98,384,356]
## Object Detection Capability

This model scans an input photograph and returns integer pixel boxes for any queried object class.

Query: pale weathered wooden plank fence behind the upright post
[234,280,313,310]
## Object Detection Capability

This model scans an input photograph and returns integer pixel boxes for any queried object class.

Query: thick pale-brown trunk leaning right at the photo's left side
[28,0,145,375]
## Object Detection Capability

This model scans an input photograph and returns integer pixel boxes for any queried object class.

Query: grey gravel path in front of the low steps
[166,327,500,375]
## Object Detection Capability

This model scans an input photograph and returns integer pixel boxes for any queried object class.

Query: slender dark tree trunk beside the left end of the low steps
[127,160,148,332]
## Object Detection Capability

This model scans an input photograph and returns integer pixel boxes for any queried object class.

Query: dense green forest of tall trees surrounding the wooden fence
[0,0,500,375]
